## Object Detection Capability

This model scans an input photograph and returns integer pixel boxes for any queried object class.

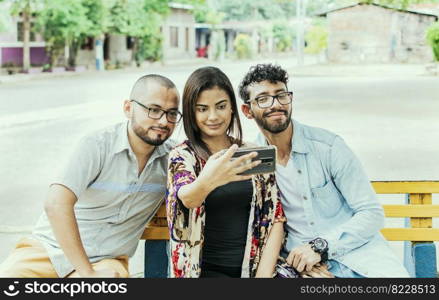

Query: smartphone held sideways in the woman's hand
[232,145,276,175]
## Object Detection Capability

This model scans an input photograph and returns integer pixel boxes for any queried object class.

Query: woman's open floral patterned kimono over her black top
[166,141,285,278]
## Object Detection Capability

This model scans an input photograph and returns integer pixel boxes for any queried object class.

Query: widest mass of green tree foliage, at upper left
[32,0,169,67]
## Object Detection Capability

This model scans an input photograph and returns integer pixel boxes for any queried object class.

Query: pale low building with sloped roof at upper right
[319,4,438,63]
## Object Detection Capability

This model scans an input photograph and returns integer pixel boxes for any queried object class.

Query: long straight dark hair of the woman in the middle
[183,67,242,160]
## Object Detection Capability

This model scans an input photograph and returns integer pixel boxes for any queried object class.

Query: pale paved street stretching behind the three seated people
[0,59,439,273]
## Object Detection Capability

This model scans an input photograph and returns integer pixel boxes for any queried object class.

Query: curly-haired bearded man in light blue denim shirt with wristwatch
[239,64,409,277]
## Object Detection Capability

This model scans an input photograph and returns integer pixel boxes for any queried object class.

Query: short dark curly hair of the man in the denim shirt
[239,64,288,102]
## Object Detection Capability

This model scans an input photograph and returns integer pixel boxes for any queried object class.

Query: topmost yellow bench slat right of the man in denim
[371,181,439,194]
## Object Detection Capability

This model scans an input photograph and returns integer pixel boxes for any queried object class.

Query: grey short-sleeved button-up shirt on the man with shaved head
[33,123,175,277]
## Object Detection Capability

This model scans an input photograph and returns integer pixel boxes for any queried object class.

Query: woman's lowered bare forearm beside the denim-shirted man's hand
[256,222,284,278]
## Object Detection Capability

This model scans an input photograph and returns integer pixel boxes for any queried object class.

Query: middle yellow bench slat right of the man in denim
[383,204,439,218]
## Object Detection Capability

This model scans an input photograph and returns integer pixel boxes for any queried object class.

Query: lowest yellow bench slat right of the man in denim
[381,228,439,242]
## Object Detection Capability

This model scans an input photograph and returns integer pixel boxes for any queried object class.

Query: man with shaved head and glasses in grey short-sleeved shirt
[0,74,181,277]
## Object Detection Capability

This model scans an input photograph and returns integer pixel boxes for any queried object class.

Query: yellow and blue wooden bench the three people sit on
[142,181,439,278]
